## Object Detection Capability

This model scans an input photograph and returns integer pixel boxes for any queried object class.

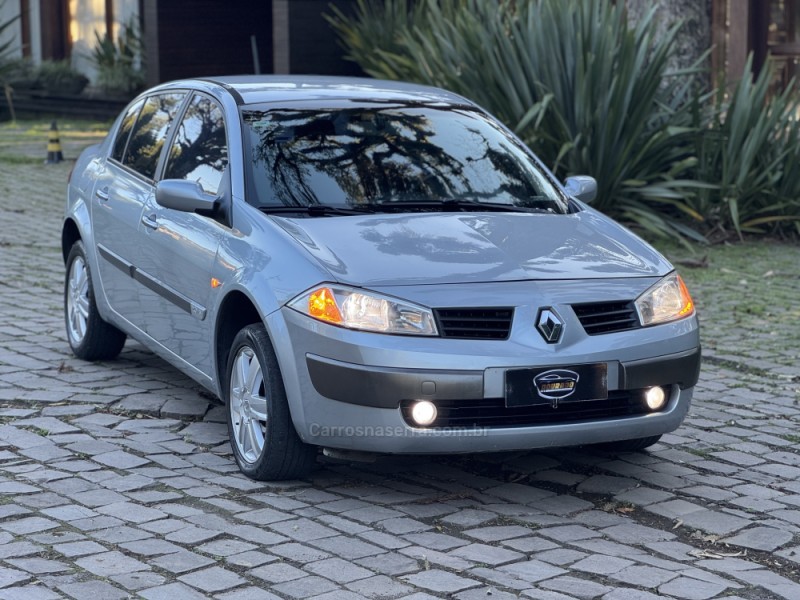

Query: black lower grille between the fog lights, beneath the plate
[400,390,650,429]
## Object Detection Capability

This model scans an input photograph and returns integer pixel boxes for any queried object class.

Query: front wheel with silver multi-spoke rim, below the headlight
[223,323,317,481]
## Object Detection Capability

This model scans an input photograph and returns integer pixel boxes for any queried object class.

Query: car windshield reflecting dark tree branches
[243,103,567,213]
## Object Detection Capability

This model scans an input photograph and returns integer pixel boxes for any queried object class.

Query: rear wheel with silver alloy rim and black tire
[64,241,125,361]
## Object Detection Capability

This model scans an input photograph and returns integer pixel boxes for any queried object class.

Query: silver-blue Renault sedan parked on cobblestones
[62,76,700,480]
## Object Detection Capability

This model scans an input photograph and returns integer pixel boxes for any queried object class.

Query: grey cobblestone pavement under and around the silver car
[0,163,800,600]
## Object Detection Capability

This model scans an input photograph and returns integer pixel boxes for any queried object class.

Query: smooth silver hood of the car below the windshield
[270,209,672,286]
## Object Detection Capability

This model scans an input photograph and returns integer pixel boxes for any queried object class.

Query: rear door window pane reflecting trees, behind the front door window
[122,93,185,179]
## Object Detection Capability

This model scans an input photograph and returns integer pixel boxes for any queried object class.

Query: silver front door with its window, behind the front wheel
[139,94,228,376]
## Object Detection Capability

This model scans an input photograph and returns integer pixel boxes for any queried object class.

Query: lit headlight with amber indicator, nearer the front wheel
[289,285,438,335]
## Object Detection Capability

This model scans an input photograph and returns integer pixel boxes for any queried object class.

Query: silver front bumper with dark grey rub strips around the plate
[273,282,700,453]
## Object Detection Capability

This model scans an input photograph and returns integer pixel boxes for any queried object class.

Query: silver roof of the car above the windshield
[166,75,472,105]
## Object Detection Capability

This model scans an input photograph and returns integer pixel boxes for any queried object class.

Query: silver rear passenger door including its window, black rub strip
[92,92,186,329]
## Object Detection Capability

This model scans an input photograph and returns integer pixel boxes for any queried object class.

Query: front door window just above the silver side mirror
[164,94,228,196]
